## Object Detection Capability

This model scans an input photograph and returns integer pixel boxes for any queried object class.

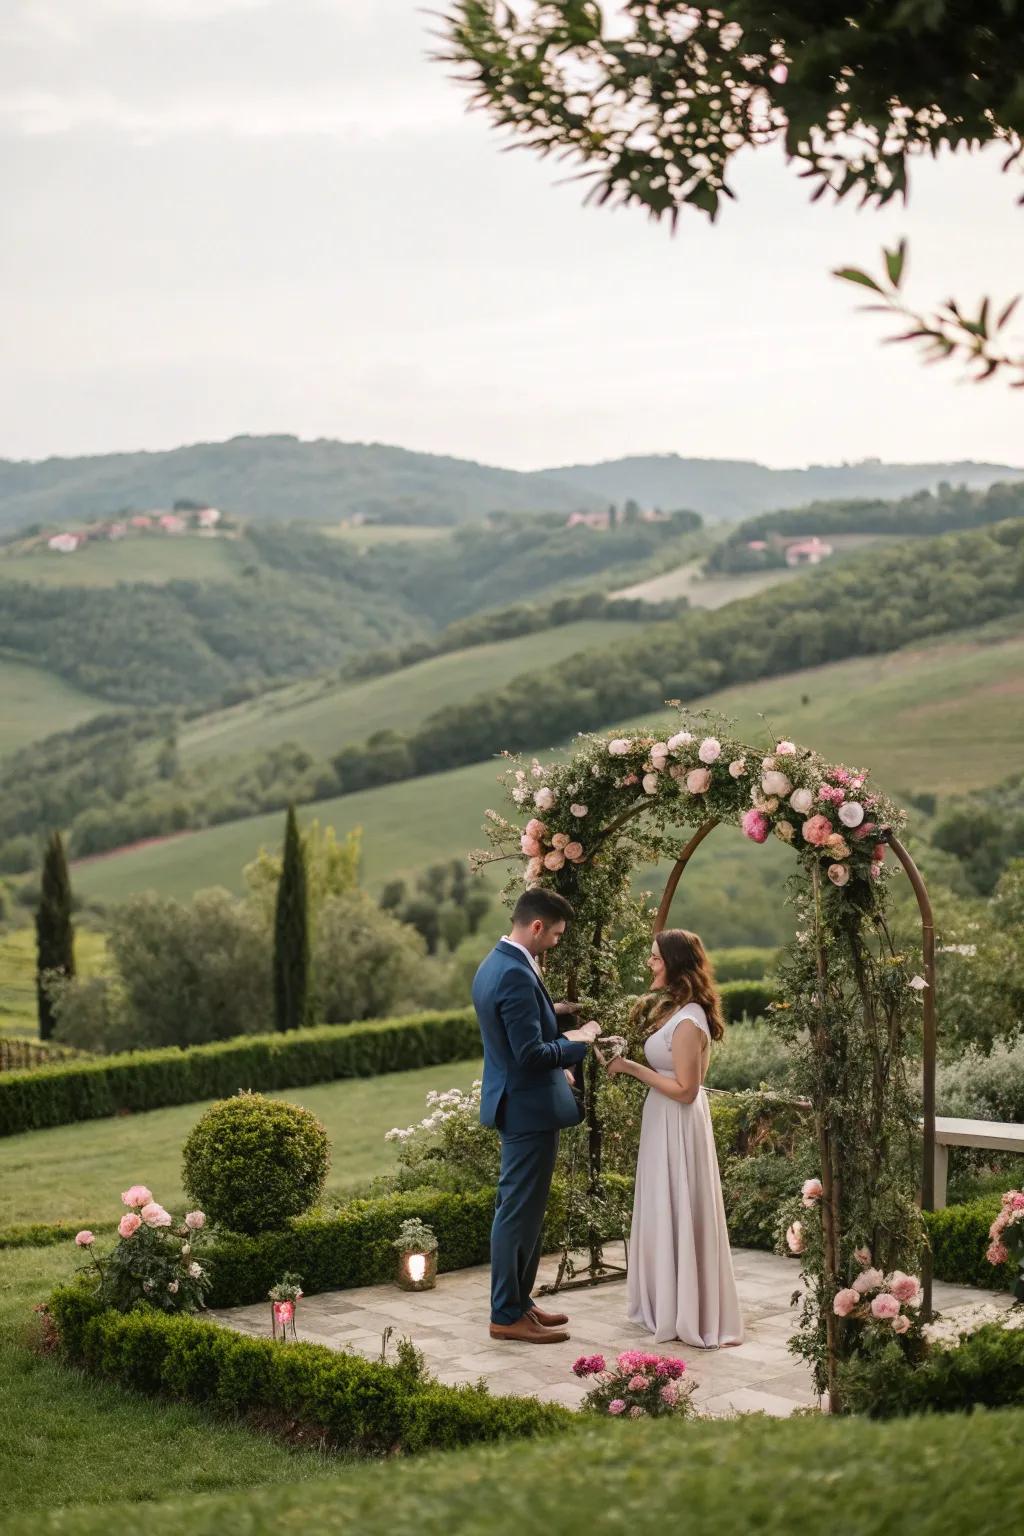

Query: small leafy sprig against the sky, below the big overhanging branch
[834,241,1024,389]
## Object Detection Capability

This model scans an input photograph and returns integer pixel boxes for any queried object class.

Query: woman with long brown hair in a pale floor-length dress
[606,928,743,1349]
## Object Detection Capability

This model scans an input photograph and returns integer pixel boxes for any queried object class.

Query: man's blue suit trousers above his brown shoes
[491,1129,559,1322]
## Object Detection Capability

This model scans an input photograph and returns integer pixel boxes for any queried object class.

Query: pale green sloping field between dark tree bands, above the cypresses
[178,621,642,768]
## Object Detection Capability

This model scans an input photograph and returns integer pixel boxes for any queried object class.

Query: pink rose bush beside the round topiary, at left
[75,1184,210,1312]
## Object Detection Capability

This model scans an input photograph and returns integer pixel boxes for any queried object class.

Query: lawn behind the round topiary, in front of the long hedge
[0,1061,481,1227]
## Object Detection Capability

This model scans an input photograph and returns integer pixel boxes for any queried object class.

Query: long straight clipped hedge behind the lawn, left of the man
[0,1009,481,1137]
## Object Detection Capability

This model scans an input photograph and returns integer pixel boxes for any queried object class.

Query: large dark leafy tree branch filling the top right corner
[441,0,1024,224]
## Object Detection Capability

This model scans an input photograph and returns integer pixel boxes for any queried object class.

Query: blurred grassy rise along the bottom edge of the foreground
[9,1412,1024,1536]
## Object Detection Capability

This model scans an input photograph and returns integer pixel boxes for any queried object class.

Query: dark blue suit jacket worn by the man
[473,938,586,1134]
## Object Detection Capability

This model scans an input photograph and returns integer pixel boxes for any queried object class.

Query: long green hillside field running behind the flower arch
[74,621,1024,946]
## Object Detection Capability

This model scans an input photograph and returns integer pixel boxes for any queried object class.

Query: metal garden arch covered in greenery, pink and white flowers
[474,716,935,1407]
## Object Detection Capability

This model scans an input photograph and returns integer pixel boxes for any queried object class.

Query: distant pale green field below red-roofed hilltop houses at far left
[0,533,243,587]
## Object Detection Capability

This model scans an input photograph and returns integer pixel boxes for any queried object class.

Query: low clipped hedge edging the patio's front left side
[49,1286,579,1455]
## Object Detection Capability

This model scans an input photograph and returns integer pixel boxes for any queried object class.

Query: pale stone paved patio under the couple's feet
[210,1247,1010,1418]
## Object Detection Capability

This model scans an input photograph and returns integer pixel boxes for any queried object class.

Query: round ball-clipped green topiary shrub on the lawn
[183,1094,330,1233]
